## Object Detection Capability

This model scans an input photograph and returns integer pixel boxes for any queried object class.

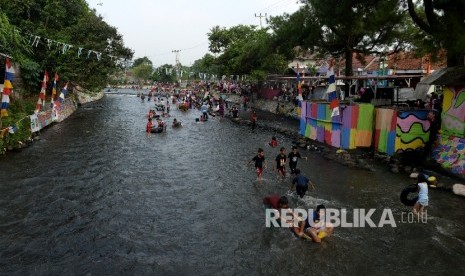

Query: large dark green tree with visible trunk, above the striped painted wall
[272,0,405,76]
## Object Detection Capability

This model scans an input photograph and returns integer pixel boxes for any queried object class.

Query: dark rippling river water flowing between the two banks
[0,90,465,275]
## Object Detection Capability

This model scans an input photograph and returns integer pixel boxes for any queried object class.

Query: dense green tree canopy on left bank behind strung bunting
[0,0,133,92]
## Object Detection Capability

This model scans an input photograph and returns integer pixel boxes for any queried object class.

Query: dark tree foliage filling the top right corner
[407,0,465,67]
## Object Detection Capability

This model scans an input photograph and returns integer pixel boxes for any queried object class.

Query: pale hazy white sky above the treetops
[87,0,299,66]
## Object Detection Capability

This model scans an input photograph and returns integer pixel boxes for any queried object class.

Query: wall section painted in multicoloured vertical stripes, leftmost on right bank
[300,102,374,149]
